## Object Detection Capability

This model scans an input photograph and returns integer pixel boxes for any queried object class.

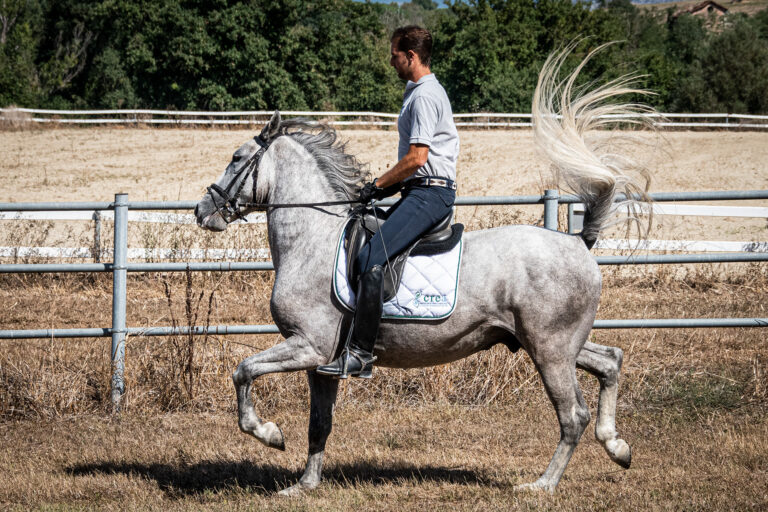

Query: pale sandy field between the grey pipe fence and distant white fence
[0,128,768,246]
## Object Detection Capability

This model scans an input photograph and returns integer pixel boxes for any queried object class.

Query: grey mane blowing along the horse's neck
[277,118,371,200]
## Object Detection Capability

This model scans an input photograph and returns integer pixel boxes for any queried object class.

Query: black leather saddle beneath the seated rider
[344,207,464,302]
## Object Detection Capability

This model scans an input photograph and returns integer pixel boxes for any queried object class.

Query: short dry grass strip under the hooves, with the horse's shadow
[0,404,768,511]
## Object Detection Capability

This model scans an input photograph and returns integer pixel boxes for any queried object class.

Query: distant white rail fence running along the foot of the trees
[0,108,768,129]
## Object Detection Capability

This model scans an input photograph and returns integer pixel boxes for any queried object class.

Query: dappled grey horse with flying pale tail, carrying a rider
[195,46,645,495]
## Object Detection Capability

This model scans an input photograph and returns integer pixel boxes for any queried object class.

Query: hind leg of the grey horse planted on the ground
[516,343,590,492]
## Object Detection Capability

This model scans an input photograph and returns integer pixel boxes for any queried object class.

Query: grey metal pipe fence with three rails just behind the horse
[0,190,768,407]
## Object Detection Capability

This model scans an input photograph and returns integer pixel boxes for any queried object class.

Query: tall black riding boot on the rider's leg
[316,265,384,379]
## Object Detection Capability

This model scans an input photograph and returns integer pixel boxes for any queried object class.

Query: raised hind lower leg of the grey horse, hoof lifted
[576,342,632,469]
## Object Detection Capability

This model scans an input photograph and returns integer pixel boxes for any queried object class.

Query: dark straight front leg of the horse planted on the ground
[280,370,339,496]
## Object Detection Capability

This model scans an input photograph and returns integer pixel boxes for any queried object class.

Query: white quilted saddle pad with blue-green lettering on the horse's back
[333,225,463,320]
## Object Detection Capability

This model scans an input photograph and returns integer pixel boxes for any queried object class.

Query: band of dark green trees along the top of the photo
[0,0,768,113]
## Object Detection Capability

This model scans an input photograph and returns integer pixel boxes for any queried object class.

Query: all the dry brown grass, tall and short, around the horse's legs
[0,265,768,510]
